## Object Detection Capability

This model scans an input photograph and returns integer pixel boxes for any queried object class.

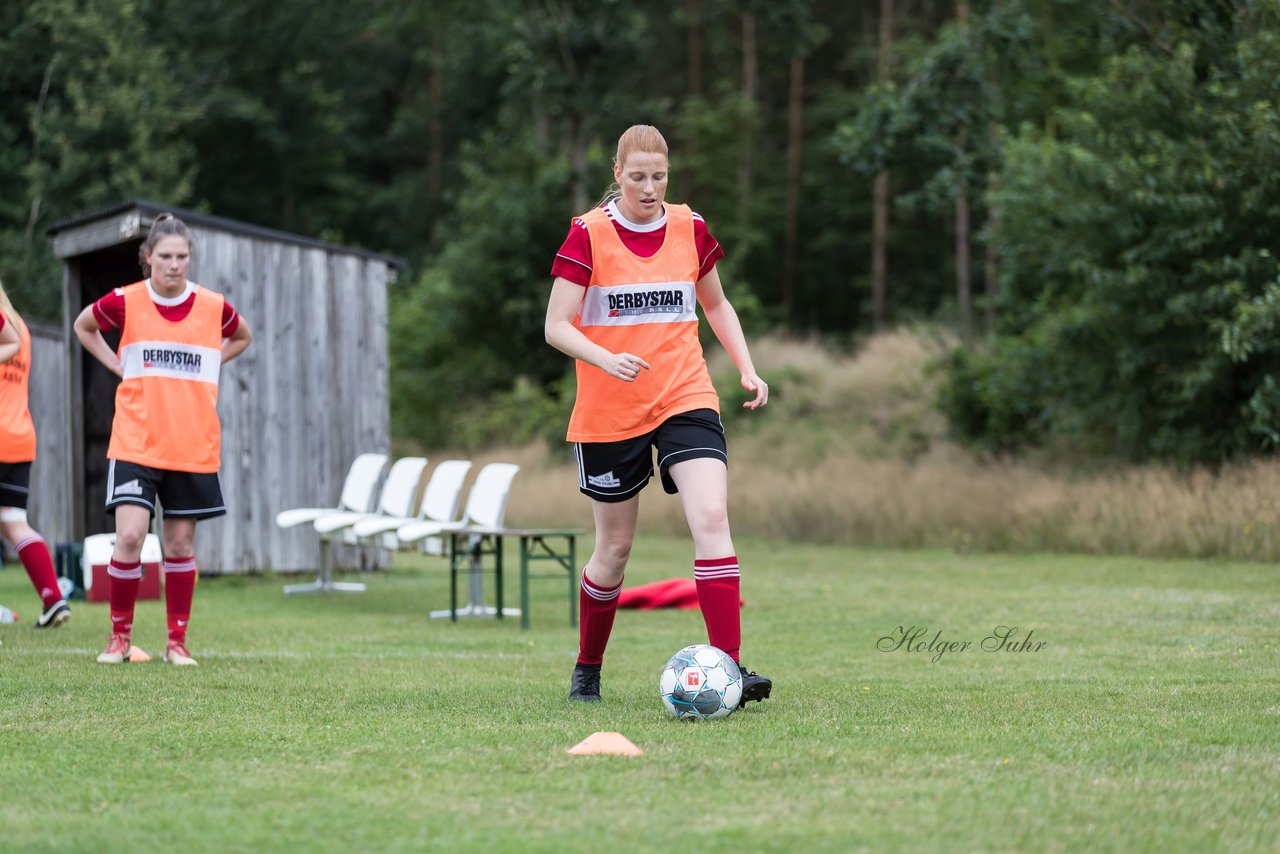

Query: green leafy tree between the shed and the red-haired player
[389,133,568,447]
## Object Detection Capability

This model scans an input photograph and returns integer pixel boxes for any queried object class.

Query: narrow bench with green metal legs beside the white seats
[448,526,582,629]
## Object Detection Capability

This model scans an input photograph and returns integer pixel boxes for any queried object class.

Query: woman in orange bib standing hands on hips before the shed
[76,214,252,666]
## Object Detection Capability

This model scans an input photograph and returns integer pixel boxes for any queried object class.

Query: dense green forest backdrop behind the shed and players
[10,0,1280,461]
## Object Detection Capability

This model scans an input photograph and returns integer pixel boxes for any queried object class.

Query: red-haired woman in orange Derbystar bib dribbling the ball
[545,124,773,705]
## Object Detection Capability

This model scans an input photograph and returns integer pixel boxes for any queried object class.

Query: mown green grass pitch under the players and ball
[0,538,1280,853]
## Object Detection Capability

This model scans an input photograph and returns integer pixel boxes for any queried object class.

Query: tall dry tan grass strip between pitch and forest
[476,330,1280,561]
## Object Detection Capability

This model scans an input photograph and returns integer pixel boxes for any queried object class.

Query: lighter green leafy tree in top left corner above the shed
[0,0,198,318]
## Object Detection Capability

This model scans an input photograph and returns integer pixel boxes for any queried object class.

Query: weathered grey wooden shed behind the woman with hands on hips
[31,200,402,574]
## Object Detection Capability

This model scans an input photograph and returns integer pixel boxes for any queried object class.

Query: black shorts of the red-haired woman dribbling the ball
[577,410,728,503]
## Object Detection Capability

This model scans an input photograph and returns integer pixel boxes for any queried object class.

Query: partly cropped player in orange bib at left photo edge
[0,284,72,629]
